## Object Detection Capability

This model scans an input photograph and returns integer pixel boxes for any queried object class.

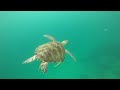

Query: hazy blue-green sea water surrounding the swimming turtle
[0,11,120,79]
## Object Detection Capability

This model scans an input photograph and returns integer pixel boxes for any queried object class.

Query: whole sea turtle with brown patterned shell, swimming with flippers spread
[23,35,76,73]
